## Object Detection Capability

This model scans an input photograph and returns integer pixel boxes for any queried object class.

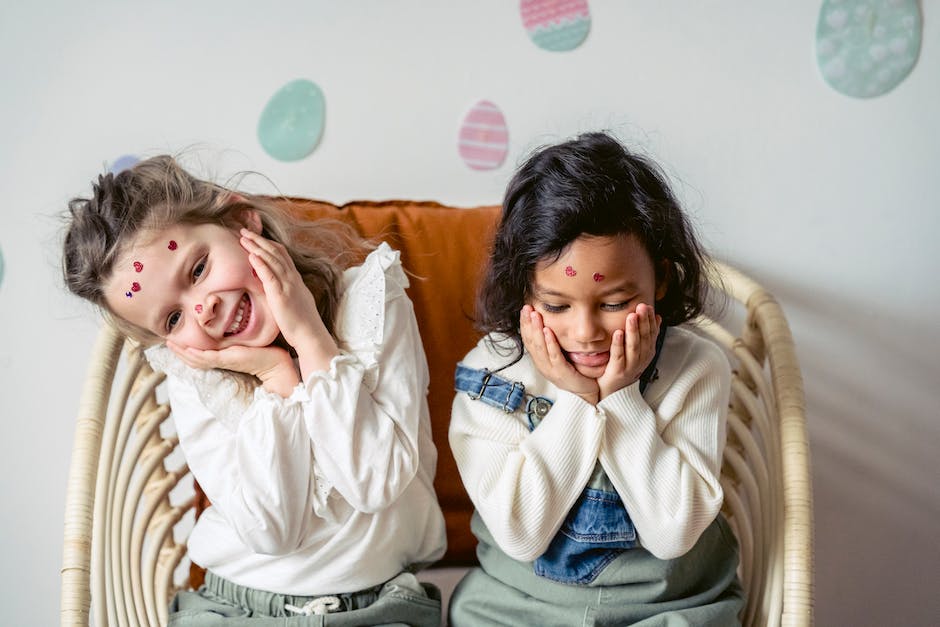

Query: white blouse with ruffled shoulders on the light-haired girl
[147,244,446,595]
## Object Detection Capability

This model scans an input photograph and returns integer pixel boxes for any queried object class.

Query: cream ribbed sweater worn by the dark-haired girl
[449,327,730,561]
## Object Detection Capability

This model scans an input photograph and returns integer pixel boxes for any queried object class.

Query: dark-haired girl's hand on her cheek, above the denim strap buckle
[519,305,598,405]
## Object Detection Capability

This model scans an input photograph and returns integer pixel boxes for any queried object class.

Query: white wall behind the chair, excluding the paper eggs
[0,0,940,625]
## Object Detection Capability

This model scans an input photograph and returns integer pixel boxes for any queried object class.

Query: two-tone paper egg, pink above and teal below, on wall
[519,0,591,52]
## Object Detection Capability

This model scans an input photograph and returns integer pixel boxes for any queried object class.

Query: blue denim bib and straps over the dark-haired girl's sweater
[455,326,666,585]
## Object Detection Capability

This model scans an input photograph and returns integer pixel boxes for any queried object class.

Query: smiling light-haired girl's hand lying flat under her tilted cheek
[166,340,300,397]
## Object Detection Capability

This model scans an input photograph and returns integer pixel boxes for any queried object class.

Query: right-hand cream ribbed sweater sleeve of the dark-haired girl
[598,340,730,559]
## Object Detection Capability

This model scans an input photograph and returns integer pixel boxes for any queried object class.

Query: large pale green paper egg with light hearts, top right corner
[816,0,922,98]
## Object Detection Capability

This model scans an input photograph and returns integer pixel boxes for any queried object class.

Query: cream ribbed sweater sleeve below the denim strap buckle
[449,348,605,561]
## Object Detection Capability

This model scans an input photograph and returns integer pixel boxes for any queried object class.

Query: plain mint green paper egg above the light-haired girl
[258,79,326,161]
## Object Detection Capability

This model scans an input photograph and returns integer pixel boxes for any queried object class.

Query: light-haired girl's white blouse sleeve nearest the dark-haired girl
[292,244,428,513]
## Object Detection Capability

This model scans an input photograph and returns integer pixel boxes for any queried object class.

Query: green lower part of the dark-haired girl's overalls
[448,514,744,627]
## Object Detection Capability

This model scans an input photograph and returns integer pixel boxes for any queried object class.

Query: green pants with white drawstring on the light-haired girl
[168,572,441,627]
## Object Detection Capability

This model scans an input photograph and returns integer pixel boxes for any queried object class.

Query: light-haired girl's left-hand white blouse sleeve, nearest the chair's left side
[167,375,317,555]
